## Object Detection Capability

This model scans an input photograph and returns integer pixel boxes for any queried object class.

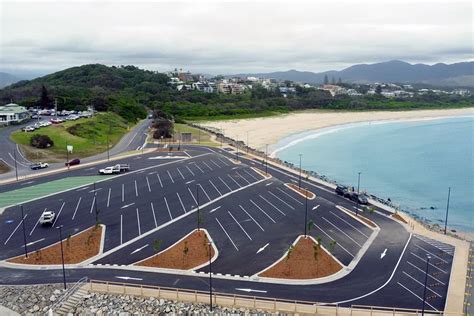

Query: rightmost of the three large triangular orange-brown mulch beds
[259,237,342,279]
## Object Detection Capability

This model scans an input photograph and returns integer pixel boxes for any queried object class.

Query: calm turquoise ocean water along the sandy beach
[272,116,474,232]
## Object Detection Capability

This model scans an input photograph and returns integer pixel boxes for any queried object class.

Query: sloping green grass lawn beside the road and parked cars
[11,112,131,160]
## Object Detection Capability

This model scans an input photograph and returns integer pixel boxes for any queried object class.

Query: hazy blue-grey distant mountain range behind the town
[234,60,474,87]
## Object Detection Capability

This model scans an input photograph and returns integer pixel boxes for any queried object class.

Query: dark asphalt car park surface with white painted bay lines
[0,146,453,310]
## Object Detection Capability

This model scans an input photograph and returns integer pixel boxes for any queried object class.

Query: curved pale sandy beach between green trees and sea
[200,108,474,150]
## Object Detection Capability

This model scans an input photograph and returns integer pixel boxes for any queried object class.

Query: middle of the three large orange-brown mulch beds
[136,230,214,270]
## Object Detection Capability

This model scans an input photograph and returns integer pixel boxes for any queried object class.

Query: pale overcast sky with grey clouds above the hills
[0,0,473,74]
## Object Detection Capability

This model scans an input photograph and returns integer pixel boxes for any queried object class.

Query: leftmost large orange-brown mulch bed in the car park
[7,226,102,265]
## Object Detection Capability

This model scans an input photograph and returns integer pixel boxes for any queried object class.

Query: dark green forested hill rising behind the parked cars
[0,64,169,121]
